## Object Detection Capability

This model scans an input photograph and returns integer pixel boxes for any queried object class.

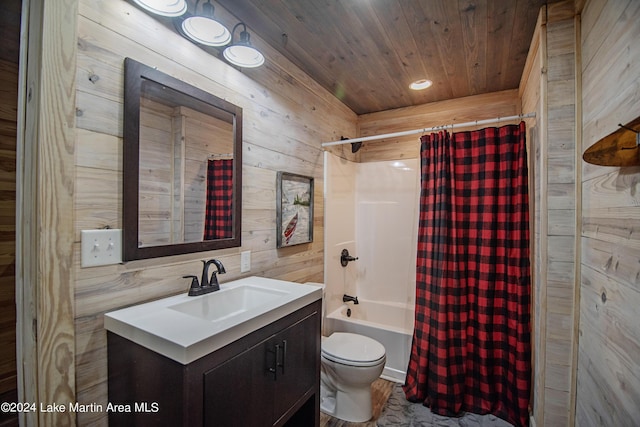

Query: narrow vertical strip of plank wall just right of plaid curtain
[540,8,576,425]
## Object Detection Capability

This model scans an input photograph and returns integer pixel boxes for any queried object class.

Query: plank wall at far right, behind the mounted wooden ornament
[576,0,640,427]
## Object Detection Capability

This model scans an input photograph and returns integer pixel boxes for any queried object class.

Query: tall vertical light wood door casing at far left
[16,0,77,426]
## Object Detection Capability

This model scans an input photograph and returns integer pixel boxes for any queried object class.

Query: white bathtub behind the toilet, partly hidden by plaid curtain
[325,299,414,383]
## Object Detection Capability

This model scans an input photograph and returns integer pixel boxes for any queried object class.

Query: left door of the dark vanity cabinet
[203,341,274,427]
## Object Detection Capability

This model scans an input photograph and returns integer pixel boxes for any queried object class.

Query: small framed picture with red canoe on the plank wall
[276,171,313,249]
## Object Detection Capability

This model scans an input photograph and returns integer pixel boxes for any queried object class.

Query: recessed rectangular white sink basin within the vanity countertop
[169,285,289,322]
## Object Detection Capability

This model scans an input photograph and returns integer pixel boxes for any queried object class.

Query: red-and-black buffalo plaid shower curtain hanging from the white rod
[404,122,531,426]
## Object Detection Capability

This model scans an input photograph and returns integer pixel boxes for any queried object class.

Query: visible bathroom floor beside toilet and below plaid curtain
[320,379,513,427]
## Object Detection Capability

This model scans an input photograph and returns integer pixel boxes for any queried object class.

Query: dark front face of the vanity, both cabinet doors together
[203,312,320,427]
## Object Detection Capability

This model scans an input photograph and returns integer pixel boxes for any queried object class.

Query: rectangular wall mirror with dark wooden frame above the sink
[123,58,242,261]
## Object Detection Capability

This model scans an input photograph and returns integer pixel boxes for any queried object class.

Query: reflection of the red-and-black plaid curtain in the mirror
[204,159,233,240]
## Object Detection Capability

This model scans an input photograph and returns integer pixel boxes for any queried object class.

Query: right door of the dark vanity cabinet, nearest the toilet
[271,313,320,420]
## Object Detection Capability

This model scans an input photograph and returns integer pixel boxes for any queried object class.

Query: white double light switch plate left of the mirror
[80,228,122,267]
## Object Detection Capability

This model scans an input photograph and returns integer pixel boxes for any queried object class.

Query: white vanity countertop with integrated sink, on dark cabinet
[104,277,322,365]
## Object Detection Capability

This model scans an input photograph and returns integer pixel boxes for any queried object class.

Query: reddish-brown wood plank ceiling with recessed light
[217,0,547,114]
